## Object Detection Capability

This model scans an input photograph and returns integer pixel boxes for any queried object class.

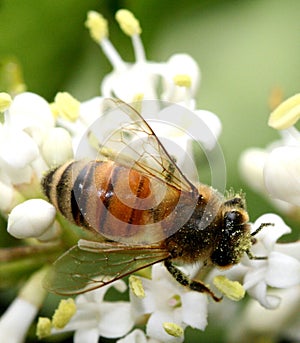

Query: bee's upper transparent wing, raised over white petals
[78,99,195,194]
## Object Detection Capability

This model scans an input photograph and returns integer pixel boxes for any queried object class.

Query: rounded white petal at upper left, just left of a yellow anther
[9,92,54,131]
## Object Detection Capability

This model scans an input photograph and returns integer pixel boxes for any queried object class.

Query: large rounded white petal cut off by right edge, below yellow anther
[264,146,300,206]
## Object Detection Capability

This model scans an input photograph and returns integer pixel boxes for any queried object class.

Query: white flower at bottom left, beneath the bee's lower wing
[52,280,135,343]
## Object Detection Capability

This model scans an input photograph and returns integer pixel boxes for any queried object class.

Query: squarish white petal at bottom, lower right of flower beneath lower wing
[98,301,134,338]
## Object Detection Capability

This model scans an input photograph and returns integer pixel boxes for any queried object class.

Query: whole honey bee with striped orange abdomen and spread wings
[42,99,264,301]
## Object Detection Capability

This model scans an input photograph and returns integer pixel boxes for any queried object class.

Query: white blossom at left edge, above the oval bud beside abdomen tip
[0,93,54,214]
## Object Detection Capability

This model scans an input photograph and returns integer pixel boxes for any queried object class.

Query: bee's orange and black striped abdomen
[42,161,179,239]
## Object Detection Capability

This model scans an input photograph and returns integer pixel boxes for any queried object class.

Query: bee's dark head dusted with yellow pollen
[210,206,252,267]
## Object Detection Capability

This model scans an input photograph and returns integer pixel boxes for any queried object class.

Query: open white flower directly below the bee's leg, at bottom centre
[130,264,207,342]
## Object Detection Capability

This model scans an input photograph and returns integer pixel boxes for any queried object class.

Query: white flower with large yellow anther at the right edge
[240,94,300,213]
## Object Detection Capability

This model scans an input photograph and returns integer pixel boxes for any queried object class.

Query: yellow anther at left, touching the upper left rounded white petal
[54,92,80,121]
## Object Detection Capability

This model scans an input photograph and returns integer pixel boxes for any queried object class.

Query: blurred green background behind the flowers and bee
[0,0,300,342]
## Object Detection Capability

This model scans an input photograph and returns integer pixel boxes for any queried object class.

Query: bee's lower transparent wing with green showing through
[44,240,169,295]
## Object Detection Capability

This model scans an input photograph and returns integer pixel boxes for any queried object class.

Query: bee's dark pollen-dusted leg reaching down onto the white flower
[164,260,222,302]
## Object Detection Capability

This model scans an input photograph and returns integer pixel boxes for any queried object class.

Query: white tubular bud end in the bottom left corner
[0,298,38,343]
